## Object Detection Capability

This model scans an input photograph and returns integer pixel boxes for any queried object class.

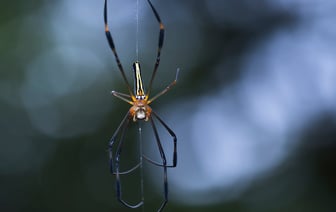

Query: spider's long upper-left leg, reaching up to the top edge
[104,0,132,94]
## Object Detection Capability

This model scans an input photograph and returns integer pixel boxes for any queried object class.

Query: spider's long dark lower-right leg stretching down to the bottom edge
[150,117,168,211]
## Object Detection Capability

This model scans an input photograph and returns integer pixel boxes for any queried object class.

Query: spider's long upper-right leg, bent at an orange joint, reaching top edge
[147,0,165,95]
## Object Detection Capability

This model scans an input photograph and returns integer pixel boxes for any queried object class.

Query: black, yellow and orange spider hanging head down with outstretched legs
[104,0,179,211]
